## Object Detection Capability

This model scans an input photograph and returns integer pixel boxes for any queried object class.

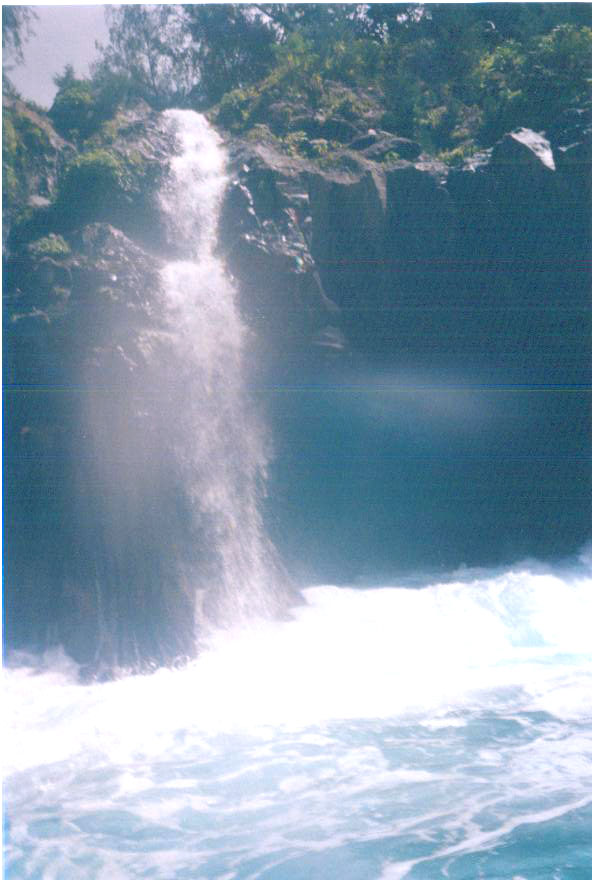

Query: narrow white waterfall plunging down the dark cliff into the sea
[152,110,290,624]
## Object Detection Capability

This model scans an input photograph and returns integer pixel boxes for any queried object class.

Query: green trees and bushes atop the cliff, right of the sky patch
[86,3,592,161]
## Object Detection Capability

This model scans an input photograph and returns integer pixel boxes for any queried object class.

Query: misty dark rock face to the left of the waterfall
[4,105,201,675]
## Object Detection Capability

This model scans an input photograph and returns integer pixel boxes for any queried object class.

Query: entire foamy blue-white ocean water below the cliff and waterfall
[4,554,592,880]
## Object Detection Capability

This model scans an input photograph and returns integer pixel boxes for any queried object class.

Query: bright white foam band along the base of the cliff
[5,571,592,770]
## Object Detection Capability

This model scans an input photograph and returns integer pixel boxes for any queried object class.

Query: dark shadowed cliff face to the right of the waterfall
[217,120,592,581]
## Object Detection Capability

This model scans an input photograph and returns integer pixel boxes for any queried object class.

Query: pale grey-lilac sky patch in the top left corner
[10,5,107,107]
